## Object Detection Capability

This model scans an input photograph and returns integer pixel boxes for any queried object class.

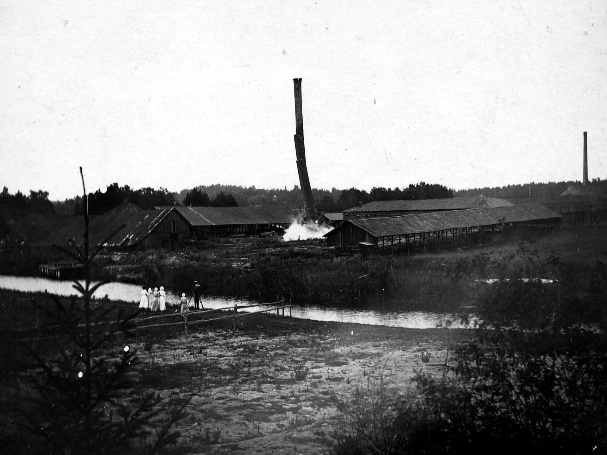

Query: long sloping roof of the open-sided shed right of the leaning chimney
[325,204,561,238]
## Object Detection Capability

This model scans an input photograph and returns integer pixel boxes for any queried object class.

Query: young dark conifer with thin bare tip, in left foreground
[27,168,186,455]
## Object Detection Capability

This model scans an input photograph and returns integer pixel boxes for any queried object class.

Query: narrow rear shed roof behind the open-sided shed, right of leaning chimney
[346,196,513,213]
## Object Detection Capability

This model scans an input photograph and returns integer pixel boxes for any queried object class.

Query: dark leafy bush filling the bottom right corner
[333,248,607,455]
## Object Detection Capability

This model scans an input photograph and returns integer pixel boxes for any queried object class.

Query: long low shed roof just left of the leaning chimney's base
[174,207,295,226]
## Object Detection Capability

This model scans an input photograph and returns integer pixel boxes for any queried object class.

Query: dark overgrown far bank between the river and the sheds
[0,224,607,312]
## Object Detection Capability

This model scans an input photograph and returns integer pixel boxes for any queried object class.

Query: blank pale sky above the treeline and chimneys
[0,0,607,200]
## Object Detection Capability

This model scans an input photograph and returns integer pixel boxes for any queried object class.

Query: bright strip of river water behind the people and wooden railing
[0,275,468,329]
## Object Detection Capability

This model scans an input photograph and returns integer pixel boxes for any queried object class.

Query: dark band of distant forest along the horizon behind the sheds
[0,178,607,223]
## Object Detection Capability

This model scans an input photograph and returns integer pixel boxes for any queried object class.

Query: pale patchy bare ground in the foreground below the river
[135,318,466,454]
